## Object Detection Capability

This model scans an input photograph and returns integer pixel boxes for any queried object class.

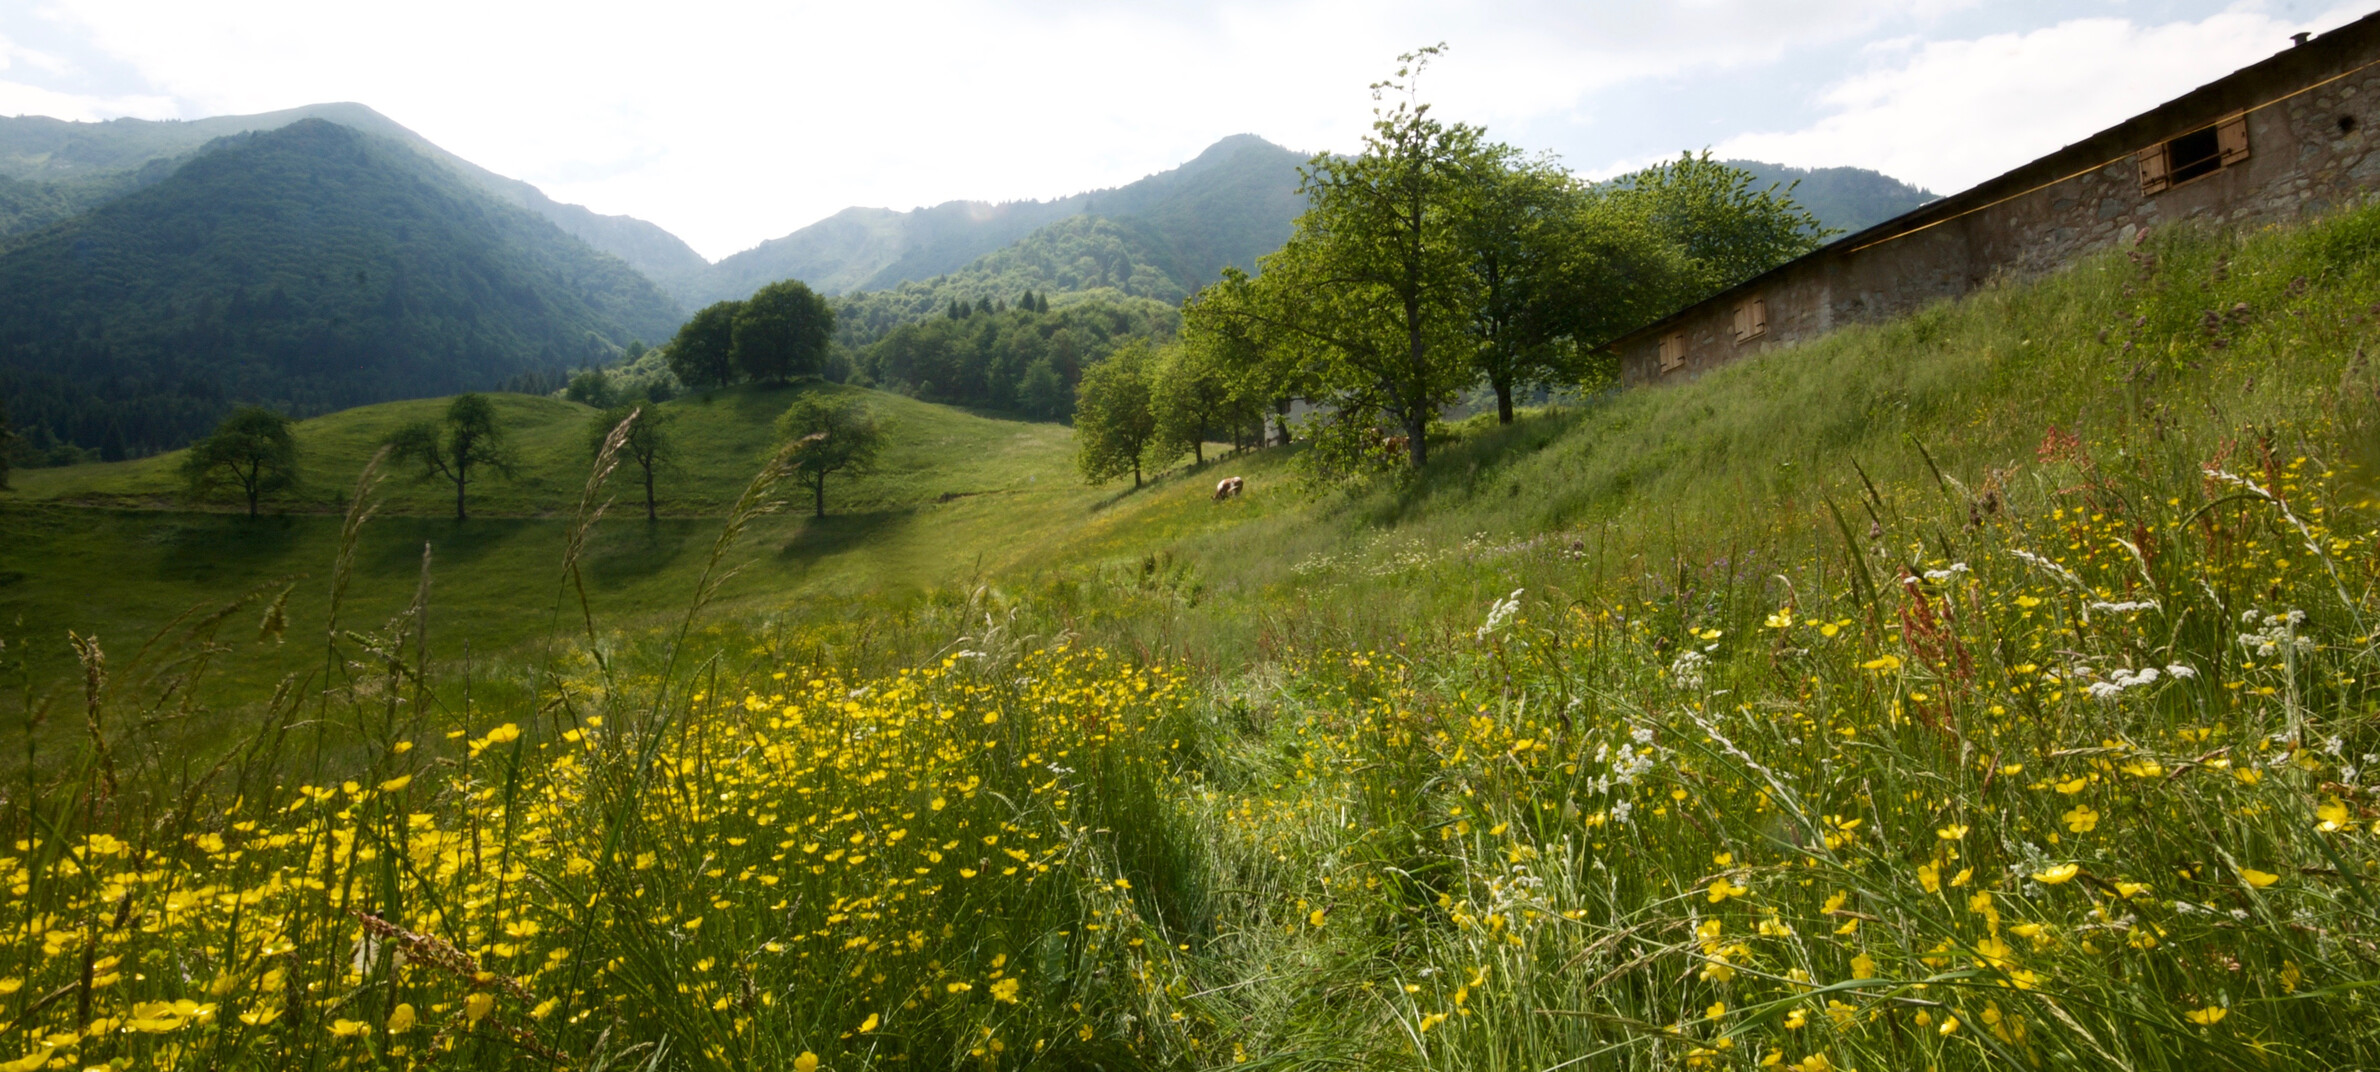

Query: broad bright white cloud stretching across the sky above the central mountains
[18,0,1973,257]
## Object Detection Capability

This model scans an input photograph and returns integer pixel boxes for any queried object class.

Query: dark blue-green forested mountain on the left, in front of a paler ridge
[0,119,678,455]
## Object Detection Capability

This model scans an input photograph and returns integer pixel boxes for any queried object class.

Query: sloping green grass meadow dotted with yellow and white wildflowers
[0,210,2380,1072]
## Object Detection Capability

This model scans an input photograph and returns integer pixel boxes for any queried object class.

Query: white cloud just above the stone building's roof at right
[1714,5,2366,193]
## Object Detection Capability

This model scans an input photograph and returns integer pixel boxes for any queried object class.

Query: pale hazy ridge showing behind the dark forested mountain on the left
[0,102,709,279]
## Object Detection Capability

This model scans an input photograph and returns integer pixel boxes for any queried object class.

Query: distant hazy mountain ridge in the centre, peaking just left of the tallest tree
[678,133,1307,307]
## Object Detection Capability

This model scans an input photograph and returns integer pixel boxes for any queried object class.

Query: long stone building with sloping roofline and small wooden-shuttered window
[1614,14,2380,386]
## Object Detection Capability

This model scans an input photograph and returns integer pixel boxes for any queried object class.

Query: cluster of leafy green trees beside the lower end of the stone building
[1076,45,1830,484]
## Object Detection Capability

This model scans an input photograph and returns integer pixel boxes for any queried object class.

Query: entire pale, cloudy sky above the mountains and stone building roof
[0,0,2380,257]
